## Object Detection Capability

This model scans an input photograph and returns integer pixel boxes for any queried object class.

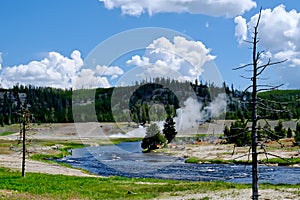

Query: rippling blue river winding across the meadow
[58,142,300,184]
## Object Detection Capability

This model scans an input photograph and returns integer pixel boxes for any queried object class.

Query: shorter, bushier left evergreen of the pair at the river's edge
[141,123,166,152]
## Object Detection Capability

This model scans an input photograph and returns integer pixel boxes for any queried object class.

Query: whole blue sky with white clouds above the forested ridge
[0,0,300,89]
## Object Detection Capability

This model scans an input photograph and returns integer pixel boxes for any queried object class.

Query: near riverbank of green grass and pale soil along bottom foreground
[0,168,300,200]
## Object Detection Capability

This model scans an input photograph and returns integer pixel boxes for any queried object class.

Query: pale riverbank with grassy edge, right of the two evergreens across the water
[157,138,300,167]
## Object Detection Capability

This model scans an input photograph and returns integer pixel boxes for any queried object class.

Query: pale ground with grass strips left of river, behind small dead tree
[0,123,136,177]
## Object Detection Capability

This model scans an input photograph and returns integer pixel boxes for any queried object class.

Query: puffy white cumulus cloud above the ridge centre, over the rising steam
[126,36,215,81]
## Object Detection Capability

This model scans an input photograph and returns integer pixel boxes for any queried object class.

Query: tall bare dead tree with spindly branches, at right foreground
[234,9,286,200]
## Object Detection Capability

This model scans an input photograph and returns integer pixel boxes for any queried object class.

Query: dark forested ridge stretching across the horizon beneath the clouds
[0,78,300,125]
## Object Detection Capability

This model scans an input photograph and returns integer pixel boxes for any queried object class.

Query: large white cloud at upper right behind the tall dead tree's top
[235,5,300,87]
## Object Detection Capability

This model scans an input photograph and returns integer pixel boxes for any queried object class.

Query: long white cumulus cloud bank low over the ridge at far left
[0,50,124,89]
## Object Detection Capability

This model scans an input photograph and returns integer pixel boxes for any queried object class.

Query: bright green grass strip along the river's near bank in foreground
[0,168,250,199]
